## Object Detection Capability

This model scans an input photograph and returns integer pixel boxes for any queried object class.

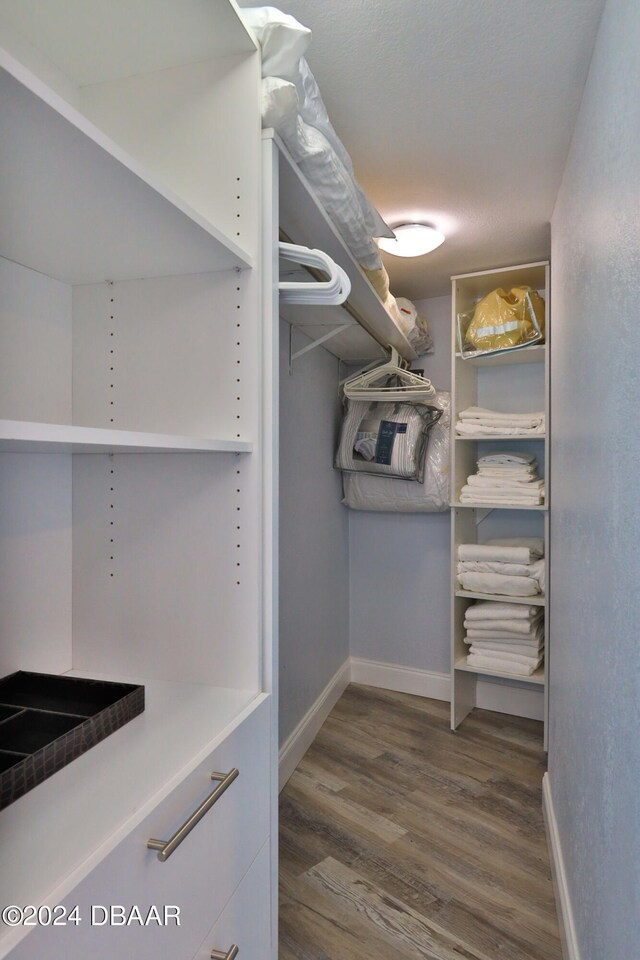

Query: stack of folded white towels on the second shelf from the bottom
[458,537,545,597]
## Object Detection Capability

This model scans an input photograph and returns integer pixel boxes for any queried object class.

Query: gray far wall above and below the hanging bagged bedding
[349,297,451,673]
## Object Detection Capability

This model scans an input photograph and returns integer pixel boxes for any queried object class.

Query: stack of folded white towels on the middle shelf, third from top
[460,453,544,507]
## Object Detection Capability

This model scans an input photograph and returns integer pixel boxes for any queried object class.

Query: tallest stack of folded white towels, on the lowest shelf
[464,600,544,677]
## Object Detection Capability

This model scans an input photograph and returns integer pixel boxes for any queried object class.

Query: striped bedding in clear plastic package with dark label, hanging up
[335,400,442,482]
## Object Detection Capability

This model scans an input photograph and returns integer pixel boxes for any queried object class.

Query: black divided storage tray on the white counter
[0,670,144,810]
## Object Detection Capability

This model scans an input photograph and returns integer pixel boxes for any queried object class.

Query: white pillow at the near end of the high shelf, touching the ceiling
[242,7,311,77]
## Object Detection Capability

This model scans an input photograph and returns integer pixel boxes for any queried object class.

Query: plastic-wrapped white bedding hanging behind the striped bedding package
[342,392,451,513]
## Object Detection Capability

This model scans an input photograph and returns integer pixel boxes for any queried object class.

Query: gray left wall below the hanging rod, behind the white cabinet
[280,321,349,744]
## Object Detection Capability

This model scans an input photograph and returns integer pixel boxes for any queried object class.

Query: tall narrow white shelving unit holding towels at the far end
[451,261,550,744]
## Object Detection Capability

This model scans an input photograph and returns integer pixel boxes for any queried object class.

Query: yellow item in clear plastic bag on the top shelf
[465,286,544,351]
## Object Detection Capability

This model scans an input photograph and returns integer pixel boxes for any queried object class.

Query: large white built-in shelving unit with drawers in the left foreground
[0,7,277,960]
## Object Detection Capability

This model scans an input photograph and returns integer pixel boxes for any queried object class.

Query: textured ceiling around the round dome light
[241,0,604,300]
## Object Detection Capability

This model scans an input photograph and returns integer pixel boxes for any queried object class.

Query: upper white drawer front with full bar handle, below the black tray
[10,699,270,960]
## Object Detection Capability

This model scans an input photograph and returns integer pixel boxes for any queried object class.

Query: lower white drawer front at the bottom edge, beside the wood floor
[194,843,271,960]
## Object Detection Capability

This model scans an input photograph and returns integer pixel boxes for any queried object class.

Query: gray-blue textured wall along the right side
[549,0,640,960]
